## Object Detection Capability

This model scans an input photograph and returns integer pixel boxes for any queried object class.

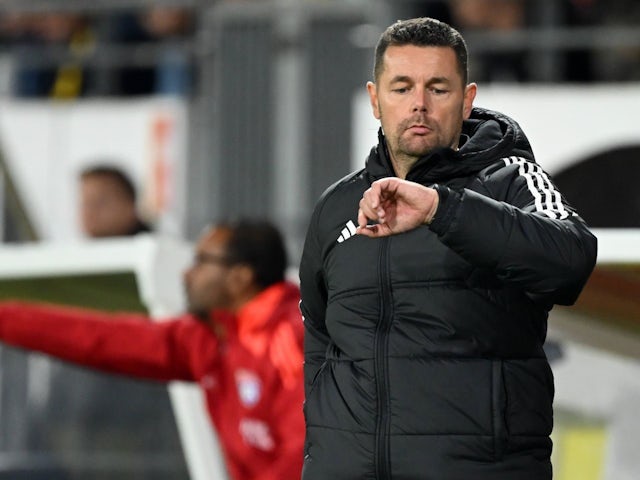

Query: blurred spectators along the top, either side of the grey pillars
[0,0,640,98]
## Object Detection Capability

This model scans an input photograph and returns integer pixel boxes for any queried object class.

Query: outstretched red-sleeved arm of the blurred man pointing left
[0,302,216,380]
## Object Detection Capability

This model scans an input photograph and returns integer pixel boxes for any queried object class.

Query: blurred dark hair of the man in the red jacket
[218,219,287,288]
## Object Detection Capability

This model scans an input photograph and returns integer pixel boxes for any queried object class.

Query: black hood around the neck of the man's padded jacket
[365,107,534,183]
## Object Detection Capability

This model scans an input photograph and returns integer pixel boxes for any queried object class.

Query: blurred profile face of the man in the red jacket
[184,228,232,319]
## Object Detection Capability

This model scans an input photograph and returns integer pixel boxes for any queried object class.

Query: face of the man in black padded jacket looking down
[367,45,476,171]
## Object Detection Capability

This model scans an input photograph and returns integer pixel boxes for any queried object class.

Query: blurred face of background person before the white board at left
[80,175,136,238]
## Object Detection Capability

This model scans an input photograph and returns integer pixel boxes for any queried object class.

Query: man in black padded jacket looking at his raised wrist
[300,18,596,480]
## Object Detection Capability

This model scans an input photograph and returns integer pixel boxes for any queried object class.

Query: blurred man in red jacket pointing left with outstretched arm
[0,221,304,480]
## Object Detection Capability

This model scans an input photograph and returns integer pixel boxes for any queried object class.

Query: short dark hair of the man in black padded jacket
[373,17,469,85]
